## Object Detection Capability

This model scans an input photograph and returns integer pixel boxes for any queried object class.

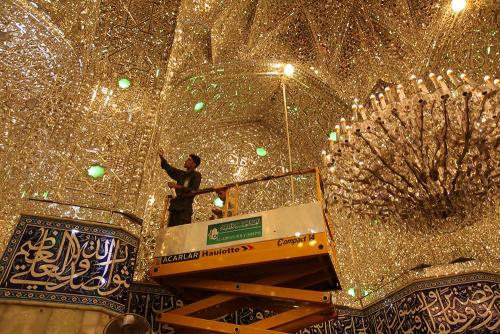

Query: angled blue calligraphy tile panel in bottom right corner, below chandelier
[366,273,500,334]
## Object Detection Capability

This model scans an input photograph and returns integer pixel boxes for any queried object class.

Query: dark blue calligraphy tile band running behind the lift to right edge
[128,273,500,334]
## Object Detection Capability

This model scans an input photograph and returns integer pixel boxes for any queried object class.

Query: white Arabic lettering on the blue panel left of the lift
[4,227,129,296]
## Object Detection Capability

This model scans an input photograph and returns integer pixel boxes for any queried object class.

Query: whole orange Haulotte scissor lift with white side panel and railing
[150,168,340,334]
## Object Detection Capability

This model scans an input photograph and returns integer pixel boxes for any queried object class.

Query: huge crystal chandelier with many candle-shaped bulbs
[322,70,500,224]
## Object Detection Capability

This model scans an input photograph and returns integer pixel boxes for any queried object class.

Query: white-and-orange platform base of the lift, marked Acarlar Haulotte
[151,202,340,289]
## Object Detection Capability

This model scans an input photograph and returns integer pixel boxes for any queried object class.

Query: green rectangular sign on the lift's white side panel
[207,217,262,245]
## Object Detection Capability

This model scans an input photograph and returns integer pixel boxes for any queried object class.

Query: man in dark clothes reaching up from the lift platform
[158,148,201,227]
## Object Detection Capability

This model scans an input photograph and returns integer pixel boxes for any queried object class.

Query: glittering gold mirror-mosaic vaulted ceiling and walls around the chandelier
[0,0,500,306]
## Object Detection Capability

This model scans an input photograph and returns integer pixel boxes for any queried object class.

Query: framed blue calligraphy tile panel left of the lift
[0,216,138,312]
